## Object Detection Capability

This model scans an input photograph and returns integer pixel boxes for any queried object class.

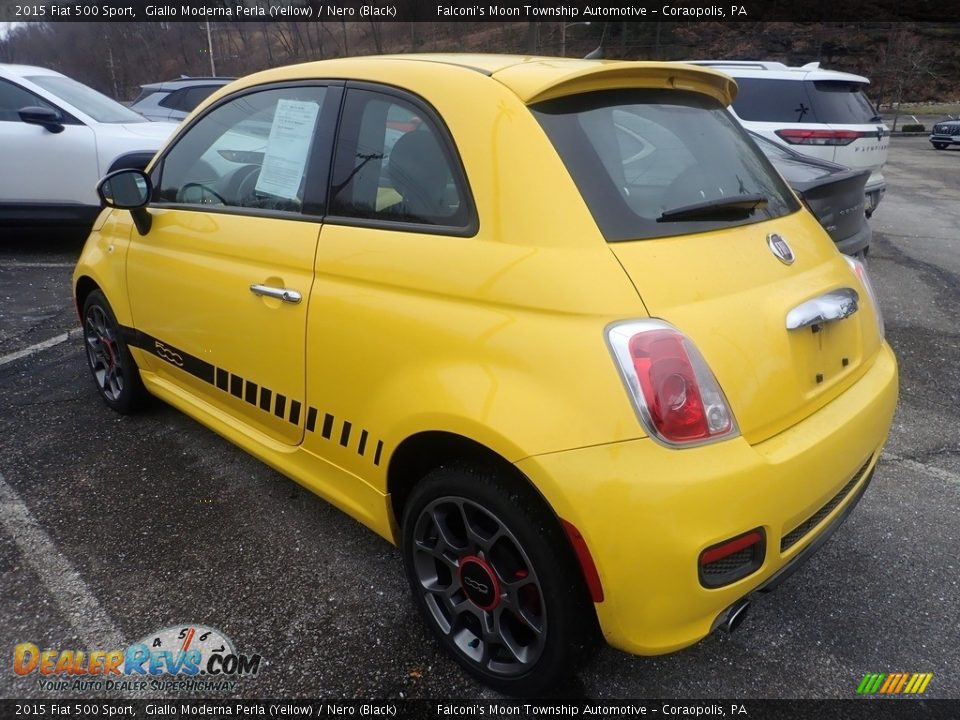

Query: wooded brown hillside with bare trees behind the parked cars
[0,21,960,105]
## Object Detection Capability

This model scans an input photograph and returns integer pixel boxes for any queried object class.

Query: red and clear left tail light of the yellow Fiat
[607,320,739,447]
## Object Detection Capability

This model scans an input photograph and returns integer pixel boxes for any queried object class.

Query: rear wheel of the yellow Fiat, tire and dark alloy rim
[402,466,597,696]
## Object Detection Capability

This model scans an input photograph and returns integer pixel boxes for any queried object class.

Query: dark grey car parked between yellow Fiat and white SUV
[750,132,873,256]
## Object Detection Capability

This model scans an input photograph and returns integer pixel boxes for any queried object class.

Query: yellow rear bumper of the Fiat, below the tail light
[518,345,897,655]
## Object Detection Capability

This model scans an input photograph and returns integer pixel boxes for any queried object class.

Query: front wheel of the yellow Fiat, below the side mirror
[83,290,147,415]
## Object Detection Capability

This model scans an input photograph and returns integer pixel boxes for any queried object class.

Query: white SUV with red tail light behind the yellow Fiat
[688,60,890,217]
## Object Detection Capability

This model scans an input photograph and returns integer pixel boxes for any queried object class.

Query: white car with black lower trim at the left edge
[0,64,177,230]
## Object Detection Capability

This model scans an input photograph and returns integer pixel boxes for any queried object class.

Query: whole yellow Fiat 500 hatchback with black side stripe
[74,55,897,693]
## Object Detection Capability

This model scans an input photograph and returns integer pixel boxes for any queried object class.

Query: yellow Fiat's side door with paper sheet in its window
[127,83,342,445]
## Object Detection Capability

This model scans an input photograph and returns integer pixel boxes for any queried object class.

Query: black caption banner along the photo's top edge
[0,0,960,22]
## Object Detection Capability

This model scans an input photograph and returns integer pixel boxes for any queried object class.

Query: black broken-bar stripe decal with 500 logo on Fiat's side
[120,326,383,465]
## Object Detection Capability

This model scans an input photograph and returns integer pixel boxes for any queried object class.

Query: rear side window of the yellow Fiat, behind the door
[330,89,472,228]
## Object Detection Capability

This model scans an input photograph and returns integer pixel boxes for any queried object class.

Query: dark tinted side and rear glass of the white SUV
[733,78,880,125]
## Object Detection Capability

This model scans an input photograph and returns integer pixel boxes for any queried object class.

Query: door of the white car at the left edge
[0,78,99,205]
